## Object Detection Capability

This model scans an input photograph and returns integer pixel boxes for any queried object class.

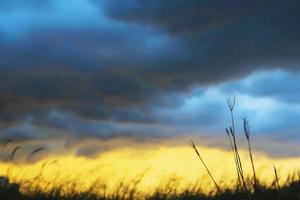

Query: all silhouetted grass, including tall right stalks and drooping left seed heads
[0,98,300,200]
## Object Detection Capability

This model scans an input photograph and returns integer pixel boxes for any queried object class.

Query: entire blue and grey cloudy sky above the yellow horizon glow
[0,0,300,159]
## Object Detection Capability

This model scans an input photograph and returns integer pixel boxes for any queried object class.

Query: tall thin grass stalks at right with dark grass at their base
[192,97,300,200]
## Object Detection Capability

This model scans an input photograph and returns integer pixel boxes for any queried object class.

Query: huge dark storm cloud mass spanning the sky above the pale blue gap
[0,0,300,128]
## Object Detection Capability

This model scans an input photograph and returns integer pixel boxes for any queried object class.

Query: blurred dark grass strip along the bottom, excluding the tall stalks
[0,174,300,200]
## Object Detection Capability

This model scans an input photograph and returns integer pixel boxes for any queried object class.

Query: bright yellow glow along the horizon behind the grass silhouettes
[0,145,300,197]
